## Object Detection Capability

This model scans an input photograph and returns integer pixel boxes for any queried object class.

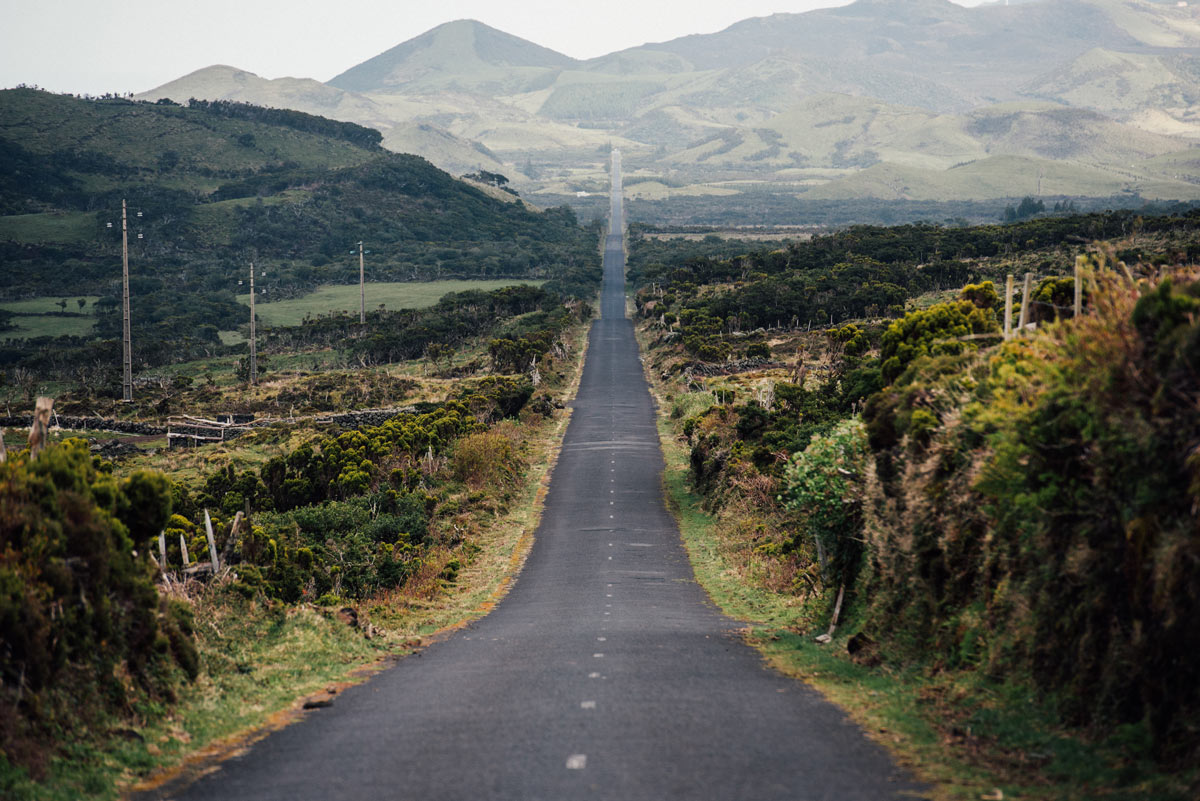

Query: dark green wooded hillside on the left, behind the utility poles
[0,89,595,376]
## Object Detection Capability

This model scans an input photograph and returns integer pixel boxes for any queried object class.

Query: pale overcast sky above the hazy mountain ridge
[0,0,980,95]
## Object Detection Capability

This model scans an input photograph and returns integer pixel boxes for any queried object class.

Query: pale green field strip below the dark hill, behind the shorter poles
[238,278,545,326]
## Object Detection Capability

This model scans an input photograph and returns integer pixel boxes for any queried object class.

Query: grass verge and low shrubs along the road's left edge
[0,297,590,799]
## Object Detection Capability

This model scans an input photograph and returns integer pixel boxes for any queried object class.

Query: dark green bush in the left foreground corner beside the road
[0,439,189,767]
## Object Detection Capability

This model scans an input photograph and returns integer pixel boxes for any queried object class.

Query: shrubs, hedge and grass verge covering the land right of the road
[637,218,1200,799]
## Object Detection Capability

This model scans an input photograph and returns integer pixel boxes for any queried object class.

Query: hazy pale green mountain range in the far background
[136,0,1200,219]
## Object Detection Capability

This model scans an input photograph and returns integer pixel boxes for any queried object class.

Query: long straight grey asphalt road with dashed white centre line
[145,149,919,801]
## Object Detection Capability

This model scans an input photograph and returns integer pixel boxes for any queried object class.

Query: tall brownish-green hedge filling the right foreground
[864,267,1200,758]
